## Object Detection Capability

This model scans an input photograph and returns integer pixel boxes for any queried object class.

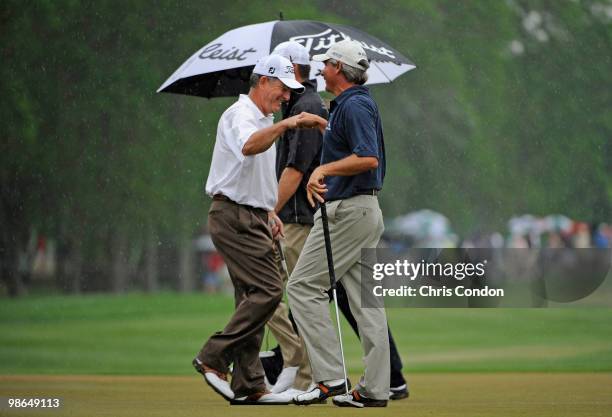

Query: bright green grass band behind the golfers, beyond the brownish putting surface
[0,293,612,375]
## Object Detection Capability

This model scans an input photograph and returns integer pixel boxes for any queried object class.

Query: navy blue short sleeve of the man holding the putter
[344,100,380,159]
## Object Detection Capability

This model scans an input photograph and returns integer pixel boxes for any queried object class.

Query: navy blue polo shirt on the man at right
[321,86,385,201]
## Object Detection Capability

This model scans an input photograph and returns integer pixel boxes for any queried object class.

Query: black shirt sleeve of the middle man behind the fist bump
[287,103,327,174]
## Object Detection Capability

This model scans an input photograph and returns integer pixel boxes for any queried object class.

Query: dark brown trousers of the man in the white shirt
[198,200,283,397]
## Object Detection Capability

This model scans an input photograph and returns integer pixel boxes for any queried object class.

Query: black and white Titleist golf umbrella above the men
[157,20,415,98]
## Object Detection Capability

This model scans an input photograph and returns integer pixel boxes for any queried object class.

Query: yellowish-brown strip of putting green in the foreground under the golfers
[0,373,612,417]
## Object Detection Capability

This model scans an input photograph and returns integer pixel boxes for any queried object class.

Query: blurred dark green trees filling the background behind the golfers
[0,0,612,294]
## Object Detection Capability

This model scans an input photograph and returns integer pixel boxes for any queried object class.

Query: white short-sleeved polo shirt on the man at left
[206,94,278,211]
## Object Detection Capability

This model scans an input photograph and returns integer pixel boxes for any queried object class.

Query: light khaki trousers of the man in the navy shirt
[287,195,390,400]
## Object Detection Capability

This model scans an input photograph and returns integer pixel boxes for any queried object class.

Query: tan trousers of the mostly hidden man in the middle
[268,223,312,391]
